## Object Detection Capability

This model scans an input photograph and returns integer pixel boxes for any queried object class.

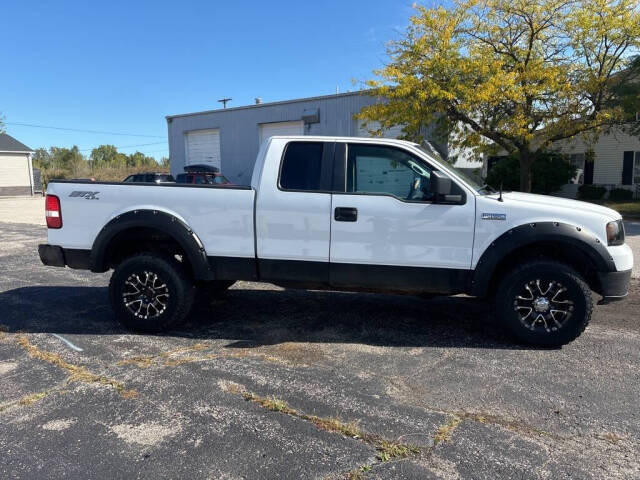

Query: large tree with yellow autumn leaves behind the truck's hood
[359,0,640,191]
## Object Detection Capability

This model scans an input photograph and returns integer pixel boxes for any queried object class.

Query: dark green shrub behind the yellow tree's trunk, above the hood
[486,152,576,195]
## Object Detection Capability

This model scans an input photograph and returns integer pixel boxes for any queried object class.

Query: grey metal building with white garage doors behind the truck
[167,92,440,185]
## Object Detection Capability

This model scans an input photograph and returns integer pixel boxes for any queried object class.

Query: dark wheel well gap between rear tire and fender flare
[104,227,193,278]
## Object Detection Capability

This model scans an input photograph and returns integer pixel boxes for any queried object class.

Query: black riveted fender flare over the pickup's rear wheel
[89,210,212,280]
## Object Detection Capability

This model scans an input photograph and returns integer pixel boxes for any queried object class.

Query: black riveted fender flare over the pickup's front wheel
[469,222,616,296]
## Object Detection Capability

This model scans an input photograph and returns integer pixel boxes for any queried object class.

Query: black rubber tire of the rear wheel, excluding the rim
[109,254,189,332]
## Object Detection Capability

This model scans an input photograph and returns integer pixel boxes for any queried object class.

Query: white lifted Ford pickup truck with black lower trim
[39,136,633,346]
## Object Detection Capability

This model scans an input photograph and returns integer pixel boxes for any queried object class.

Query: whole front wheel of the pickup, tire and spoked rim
[496,260,593,347]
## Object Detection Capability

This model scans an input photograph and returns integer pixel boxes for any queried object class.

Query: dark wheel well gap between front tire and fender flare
[487,242,600,295]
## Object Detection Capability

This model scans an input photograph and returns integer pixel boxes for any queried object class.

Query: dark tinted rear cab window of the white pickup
[280,142,325,191]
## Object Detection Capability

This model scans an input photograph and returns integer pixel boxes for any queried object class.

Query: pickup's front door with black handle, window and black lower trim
[330,143,475,293]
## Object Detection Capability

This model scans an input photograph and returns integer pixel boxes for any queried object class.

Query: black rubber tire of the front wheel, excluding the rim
[496,262,591,347]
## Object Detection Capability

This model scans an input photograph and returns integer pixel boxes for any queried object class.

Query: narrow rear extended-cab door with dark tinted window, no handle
[256,138,334,284]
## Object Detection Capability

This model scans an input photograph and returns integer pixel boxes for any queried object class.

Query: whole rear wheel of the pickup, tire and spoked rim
[109,254,195,332]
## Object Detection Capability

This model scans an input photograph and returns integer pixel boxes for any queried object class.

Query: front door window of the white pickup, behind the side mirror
[346,145,433,202]
